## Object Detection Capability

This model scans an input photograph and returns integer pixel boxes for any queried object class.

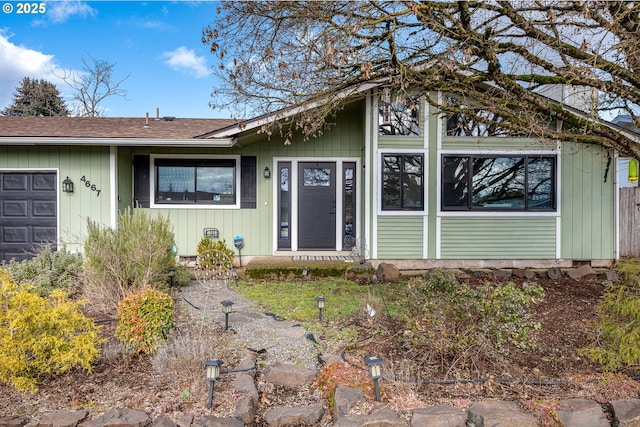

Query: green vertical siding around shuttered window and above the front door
[118,103,364,256]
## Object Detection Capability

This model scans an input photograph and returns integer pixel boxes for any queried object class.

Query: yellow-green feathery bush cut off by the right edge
[583,281,640,372]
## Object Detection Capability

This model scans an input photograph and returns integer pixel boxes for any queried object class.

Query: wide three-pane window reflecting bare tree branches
[442,155,556,211]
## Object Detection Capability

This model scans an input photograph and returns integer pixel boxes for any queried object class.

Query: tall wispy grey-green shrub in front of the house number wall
[84,209,175,312]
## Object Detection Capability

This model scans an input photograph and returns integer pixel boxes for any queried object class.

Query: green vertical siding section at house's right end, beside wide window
[560,143,615,260]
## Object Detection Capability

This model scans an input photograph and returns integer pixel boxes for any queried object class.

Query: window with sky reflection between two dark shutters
[154,159,237,205]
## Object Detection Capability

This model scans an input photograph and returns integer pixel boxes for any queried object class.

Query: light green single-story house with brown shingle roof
[0,87,632,268]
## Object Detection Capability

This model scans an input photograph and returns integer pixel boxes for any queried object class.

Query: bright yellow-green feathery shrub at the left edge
[0,270,103,391]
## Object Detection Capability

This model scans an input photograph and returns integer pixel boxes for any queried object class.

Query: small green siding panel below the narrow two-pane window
[378,216,424,259]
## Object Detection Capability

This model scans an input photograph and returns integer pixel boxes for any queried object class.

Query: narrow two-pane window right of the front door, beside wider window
[382,154,424,210]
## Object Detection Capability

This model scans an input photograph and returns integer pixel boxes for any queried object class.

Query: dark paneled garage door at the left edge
[0,172,58,261]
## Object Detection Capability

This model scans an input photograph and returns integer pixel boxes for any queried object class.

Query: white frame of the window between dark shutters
[149,154,242,209]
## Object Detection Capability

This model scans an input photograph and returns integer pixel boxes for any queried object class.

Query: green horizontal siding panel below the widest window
[440,217,556,259]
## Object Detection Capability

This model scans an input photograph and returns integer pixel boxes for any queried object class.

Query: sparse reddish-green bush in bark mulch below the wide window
[405,270,544,363]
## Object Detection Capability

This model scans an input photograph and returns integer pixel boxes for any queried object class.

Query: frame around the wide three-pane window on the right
[439,152,560,215]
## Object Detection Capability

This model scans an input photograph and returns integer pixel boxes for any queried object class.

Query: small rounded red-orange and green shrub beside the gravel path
[116,286,174,354]
